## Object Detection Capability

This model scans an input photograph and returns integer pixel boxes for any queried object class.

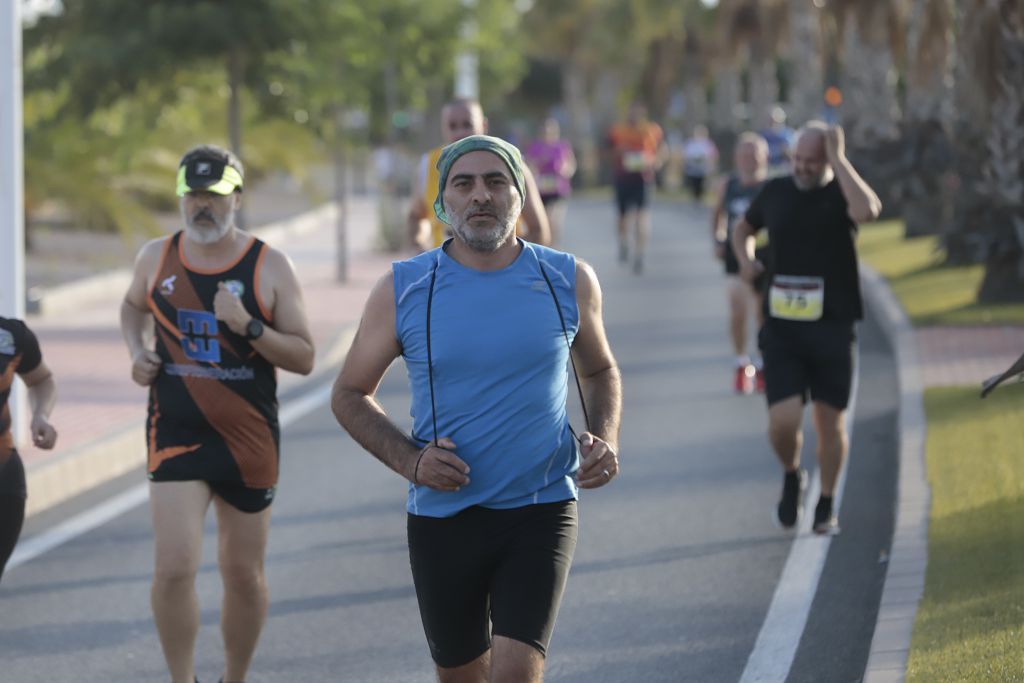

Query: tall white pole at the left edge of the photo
[0,0,26,443]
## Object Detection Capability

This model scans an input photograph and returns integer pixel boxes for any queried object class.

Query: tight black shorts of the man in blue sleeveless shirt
[408,501,578,669]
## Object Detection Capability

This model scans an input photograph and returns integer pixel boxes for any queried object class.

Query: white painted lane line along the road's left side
[7,384,331,571]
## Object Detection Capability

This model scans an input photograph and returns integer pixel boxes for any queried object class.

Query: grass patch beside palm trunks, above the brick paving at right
[857,220,1024,326]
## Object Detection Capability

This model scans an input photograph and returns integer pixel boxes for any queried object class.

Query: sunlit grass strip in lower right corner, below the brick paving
[906,384,1024,683]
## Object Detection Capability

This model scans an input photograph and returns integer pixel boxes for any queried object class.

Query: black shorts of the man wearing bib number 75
[758,317,856,411]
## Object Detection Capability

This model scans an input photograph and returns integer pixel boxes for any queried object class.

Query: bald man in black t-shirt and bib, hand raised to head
[732,121,882,533]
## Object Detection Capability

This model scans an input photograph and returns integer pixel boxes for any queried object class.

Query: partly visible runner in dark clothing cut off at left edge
[0,317,57,579]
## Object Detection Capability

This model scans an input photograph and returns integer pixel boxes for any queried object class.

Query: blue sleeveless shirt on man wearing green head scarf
[392,242,580,517]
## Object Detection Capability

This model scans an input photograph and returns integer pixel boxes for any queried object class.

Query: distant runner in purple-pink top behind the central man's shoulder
[526,117,577,247]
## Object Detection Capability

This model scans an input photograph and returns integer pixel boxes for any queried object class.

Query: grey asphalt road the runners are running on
[0,194,896,683]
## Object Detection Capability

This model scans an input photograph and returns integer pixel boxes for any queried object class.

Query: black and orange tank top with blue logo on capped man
[148,232,280,487]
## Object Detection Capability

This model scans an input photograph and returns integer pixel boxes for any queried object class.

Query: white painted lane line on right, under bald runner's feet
[739,346,860,683]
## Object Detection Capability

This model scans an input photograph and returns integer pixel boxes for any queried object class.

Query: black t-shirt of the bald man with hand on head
[744,175,864,322]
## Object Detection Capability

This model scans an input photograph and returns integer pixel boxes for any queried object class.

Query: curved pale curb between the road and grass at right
[860,261,931,683]
